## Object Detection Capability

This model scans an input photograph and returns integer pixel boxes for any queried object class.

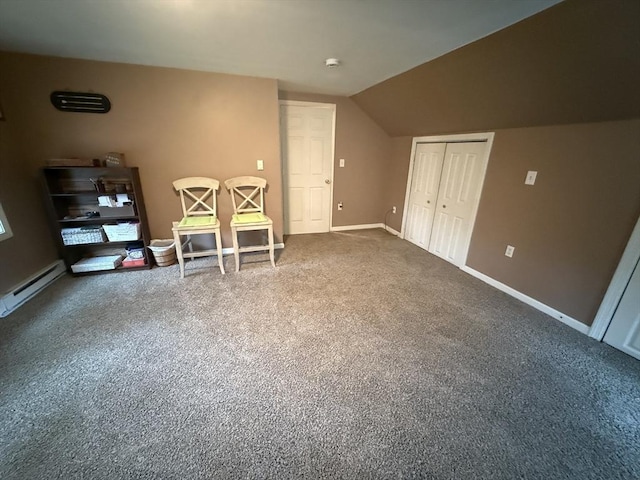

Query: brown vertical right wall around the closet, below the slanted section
[390,119,640,325]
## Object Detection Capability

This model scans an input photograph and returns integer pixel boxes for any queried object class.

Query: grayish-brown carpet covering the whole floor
[0,230,640,479]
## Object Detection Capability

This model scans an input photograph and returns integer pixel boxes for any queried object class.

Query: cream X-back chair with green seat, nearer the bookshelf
[172,177,224,278]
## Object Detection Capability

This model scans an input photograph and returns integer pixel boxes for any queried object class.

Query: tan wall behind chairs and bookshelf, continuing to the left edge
[0,53,282,291]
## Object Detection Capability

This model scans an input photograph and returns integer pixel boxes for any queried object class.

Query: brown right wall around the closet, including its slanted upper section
[352,0,640,325]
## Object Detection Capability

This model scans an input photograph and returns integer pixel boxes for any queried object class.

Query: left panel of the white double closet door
[405,143,447,250]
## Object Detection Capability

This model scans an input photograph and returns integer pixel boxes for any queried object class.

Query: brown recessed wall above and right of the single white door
[280,92,391,226]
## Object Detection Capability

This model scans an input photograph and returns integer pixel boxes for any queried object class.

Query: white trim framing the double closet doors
[400,132,495,268]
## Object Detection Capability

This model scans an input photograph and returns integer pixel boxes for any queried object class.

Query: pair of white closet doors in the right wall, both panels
[405,142,486,267]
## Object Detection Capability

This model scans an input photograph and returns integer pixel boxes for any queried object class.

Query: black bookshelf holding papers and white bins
[42,167,153,275]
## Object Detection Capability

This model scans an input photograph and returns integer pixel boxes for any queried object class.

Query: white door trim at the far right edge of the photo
[589,217,640,342]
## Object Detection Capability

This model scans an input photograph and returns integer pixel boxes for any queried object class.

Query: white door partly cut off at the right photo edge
[604,263,640,360]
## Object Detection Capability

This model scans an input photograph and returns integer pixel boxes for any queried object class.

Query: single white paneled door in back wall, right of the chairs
[280,104,335,234]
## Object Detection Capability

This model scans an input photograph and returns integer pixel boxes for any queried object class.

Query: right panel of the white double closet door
[429,142,486,267]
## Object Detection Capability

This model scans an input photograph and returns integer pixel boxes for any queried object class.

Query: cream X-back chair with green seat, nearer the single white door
[224,176,276,272]
